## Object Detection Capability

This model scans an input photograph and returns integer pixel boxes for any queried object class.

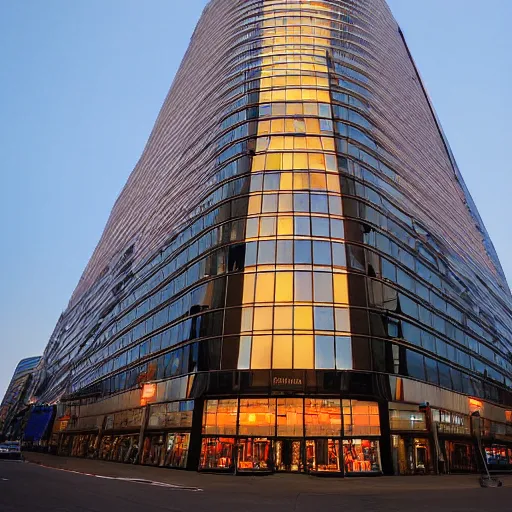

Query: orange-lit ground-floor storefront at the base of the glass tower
[52,393,512,477]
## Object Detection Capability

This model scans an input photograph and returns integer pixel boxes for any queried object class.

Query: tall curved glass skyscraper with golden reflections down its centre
[27,0,512,474]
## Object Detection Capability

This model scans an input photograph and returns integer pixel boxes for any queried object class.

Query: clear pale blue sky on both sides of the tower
[0,0,512,400]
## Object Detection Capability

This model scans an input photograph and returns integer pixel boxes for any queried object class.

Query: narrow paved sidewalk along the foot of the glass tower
[20,452,512,494]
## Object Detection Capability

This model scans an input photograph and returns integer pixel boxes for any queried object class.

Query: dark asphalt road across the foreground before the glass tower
[0,462,512,512]
